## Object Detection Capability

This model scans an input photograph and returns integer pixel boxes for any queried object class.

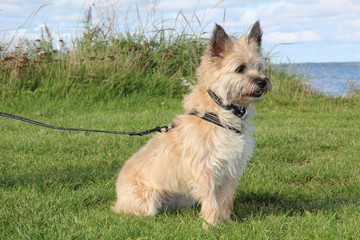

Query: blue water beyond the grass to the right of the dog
[290,62,360,97]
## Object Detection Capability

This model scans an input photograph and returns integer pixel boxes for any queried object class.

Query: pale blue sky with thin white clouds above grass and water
[0,0,360,63]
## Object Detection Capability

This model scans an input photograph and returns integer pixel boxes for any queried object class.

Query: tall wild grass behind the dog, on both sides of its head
[0,2,356,103]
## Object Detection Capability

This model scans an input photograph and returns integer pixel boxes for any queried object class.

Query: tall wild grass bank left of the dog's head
[0,4,205,99]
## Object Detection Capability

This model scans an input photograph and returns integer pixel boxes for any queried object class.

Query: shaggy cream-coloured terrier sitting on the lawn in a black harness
[112,21,271,229]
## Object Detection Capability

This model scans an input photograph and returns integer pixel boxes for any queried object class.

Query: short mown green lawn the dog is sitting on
[0,96,360,240]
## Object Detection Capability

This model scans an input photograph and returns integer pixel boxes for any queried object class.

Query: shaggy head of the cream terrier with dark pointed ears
[198,21,271,105]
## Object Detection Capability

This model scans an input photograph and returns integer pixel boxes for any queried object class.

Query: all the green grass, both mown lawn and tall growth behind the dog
[0,3,360,240]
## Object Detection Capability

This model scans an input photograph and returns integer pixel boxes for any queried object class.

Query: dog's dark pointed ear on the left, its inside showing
[210,24,230,57]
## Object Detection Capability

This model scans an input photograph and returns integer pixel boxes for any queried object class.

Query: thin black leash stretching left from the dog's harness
[0,112,175,136]
